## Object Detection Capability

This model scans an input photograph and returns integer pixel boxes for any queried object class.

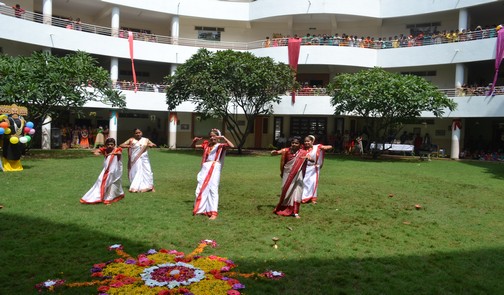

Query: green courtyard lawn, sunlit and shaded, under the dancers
[0,149,504,294]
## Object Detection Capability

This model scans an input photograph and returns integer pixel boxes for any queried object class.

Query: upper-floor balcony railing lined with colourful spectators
[0,5,497,50]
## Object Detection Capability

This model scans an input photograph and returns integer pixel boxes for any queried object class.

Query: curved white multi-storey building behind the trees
[0,0,504,155]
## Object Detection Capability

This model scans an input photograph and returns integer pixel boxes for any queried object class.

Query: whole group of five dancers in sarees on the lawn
[80,129,332,220]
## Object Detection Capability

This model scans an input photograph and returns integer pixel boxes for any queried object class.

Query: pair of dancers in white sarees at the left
[80,128,156,204]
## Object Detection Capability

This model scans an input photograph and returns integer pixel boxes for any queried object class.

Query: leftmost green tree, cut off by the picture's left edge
[0,51,126,126]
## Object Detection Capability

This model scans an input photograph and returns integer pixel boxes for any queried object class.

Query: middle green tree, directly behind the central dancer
[166,49,295,153]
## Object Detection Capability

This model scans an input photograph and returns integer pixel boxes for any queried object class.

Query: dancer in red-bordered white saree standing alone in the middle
[192,129,234,219]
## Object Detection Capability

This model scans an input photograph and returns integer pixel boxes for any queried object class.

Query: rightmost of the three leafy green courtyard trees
[328,68,457,155]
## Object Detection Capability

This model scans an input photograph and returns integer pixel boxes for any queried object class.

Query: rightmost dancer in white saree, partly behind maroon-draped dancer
[301,135,333,204]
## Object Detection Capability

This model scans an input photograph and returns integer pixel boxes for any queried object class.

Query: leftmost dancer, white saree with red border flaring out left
[80,138,124,204]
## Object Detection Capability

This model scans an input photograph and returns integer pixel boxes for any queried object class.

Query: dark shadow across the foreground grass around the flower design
[0,213,504,294]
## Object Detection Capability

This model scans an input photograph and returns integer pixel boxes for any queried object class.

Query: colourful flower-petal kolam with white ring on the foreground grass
[35,240,284,295]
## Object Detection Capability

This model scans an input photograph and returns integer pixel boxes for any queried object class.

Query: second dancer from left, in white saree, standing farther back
[120,128,156,193]
